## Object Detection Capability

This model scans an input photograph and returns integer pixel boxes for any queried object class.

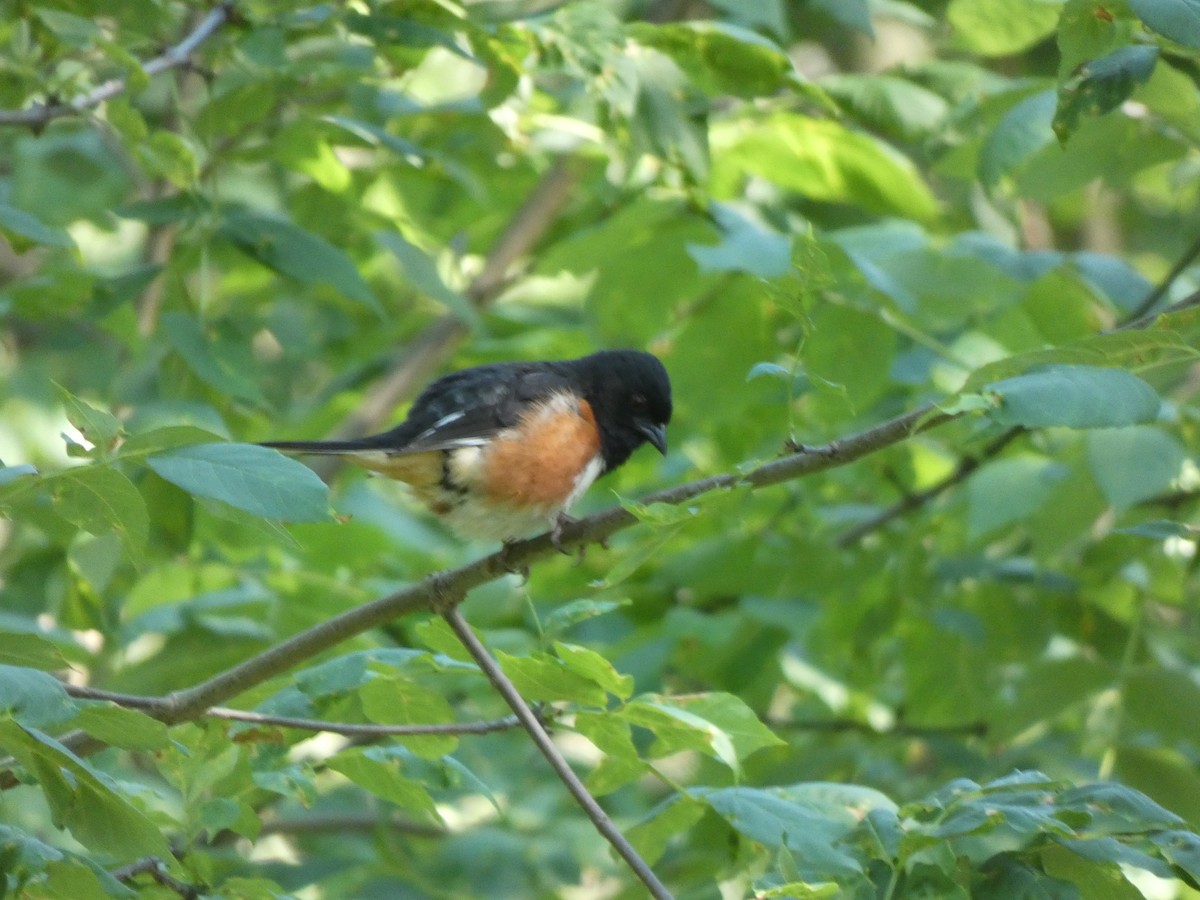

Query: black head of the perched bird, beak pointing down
[566,350,671,472]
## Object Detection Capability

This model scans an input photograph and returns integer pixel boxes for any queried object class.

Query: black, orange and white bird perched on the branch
[262,349,672,550]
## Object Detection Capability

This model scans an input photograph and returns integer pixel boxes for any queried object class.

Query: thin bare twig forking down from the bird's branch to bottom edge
[440,604,671,900]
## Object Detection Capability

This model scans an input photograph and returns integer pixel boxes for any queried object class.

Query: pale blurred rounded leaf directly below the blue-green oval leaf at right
[1087,425,1187,509]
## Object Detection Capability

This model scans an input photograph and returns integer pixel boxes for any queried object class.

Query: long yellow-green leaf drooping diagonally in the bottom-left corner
[0,721,174,860]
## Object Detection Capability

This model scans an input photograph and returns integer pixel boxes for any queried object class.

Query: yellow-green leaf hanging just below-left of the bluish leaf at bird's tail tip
[46,466,150,552]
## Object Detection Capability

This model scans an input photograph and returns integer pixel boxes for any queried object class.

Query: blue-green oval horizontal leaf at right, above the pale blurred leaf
[982,366,1160,428]
